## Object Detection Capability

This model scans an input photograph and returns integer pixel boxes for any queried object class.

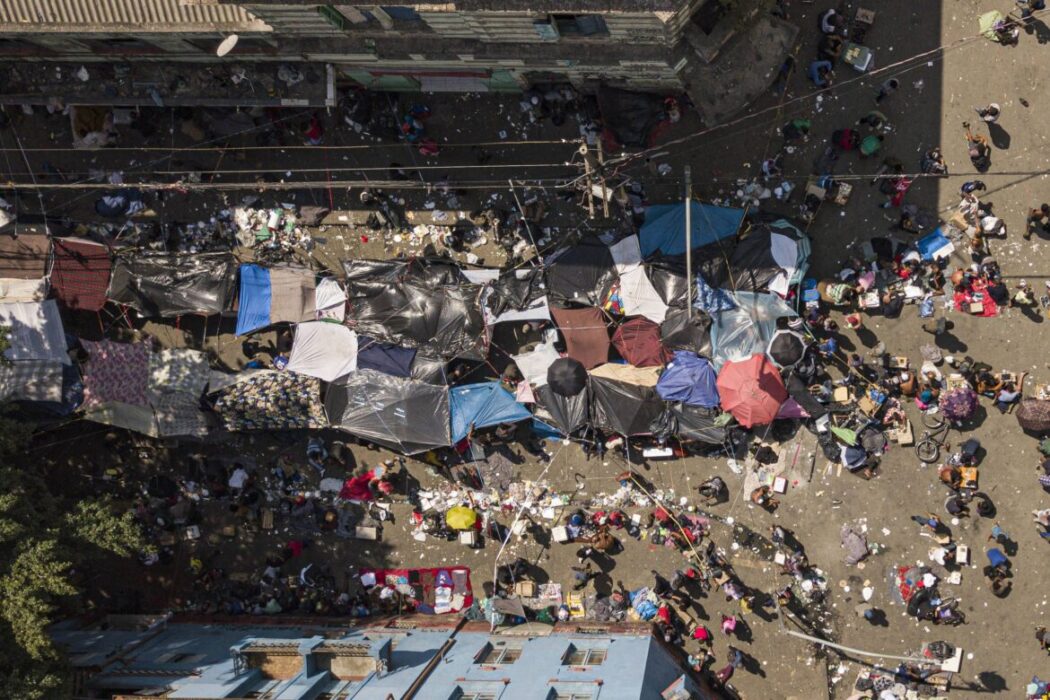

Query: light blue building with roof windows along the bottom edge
[53,617,718,700]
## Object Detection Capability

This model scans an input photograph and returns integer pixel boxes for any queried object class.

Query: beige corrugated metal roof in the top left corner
[0,0,270,33]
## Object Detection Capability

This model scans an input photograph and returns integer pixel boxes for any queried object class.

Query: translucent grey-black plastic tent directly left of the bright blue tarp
[324,369,450,454]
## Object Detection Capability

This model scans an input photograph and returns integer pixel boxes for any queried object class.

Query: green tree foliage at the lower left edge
[0,402,144,700]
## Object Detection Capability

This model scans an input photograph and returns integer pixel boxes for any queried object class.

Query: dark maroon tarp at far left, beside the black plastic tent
[51,238,112,311]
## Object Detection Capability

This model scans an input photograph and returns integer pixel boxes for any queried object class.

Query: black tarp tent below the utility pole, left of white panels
[545,238,616,306]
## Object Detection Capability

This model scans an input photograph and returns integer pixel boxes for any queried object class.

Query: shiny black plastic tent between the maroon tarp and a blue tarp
[106,253,236,317]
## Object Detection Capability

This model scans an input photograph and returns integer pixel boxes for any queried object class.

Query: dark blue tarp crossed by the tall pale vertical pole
[638,201,743,257]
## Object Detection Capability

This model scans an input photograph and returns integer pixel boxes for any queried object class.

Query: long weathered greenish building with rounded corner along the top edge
[0,0,797,123]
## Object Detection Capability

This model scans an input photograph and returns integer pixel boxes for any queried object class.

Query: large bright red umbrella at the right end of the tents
[717,354,788,428]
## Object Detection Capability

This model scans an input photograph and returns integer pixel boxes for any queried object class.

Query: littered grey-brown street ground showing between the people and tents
[10,0,1050,698]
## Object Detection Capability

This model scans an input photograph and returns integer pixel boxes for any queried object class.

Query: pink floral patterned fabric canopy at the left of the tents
[81,340,149,408]
